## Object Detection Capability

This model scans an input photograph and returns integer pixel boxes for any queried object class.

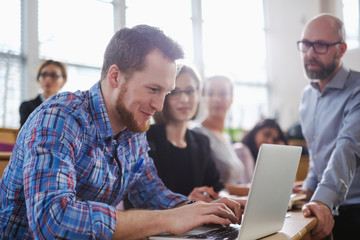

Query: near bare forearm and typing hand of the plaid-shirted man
[113,198,241,239]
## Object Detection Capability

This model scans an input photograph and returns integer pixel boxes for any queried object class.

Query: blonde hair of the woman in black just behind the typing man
[153,65,201,124]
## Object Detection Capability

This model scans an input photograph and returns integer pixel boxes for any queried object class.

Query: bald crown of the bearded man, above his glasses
[302,14,345,42]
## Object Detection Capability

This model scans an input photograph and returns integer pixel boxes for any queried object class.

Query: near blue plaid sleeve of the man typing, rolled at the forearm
[23,109,116,239]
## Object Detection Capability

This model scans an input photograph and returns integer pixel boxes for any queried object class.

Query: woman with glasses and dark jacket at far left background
[19,60,67,127]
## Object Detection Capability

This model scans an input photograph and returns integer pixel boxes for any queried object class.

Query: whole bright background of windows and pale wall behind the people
[0,0,360,137]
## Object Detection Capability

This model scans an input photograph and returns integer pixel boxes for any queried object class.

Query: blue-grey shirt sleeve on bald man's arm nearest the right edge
[312,87,360,209]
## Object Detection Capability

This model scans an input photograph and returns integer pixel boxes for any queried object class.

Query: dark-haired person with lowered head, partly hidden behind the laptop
[233,118,287,183]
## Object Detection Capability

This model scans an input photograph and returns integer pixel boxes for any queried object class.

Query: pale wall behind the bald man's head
[264,0,360,130]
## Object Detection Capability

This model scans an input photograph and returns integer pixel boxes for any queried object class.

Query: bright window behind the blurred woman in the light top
[202,0,268,129]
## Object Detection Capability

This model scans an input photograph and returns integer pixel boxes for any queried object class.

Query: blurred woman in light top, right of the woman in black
[195,76,247,196]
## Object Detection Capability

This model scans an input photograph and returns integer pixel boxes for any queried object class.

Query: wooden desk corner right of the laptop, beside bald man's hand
[261,211,317,240]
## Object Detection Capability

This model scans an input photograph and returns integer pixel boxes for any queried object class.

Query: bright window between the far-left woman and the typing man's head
[39,0,114,91]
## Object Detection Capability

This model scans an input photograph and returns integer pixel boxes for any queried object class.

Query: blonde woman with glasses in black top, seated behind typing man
[147,66,224,202]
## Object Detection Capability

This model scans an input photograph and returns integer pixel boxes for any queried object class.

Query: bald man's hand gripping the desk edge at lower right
[302,201,334,240]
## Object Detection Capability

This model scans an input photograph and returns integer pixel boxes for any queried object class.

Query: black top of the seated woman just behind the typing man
[146,125,224,196]
